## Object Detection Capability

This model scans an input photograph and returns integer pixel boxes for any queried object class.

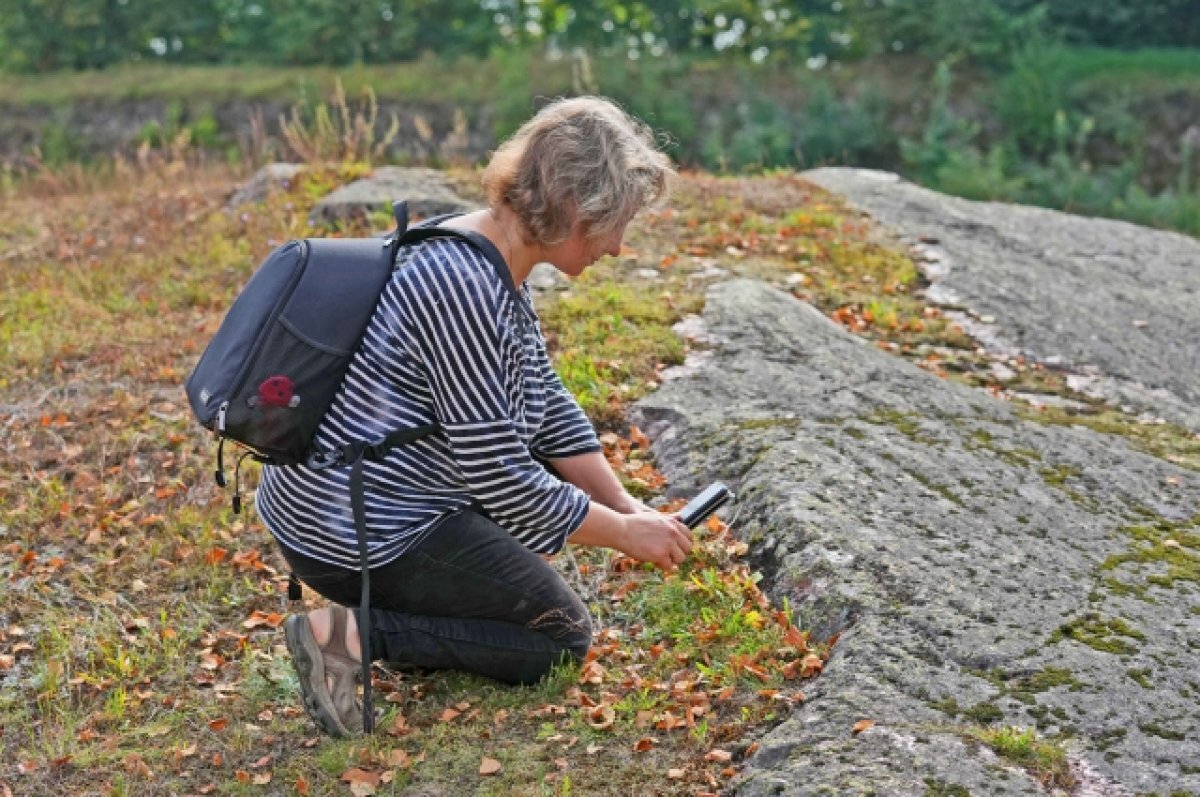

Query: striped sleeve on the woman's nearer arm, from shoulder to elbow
[398,245,588,553]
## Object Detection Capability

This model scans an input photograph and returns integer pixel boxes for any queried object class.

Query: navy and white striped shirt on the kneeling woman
[256,238,600,570]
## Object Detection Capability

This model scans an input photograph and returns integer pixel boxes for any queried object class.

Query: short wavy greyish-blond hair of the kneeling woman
[484,97,673,245]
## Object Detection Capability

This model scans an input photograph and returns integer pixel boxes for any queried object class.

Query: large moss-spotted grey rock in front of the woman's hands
[635,280,1200,797]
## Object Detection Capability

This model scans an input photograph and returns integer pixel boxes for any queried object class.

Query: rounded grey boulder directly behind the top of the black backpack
[308,166,475,223]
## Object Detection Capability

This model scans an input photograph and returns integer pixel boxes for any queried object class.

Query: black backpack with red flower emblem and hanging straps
[186,202,512,732]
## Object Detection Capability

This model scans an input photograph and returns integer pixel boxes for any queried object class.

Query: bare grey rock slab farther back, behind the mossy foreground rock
[802,168,1200,430]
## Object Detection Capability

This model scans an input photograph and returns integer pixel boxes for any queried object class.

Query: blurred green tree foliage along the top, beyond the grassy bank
[0,0,1200,72]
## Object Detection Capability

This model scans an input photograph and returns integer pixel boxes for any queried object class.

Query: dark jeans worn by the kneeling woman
[273,510,592,684]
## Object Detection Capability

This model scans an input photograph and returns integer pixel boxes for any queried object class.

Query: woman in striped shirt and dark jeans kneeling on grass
[257,97,691,736]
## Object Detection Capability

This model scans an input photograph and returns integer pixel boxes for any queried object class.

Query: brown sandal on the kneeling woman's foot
[283,605,362,737]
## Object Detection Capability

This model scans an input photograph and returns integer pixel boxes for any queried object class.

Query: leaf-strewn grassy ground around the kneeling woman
[0,166,829,796]
